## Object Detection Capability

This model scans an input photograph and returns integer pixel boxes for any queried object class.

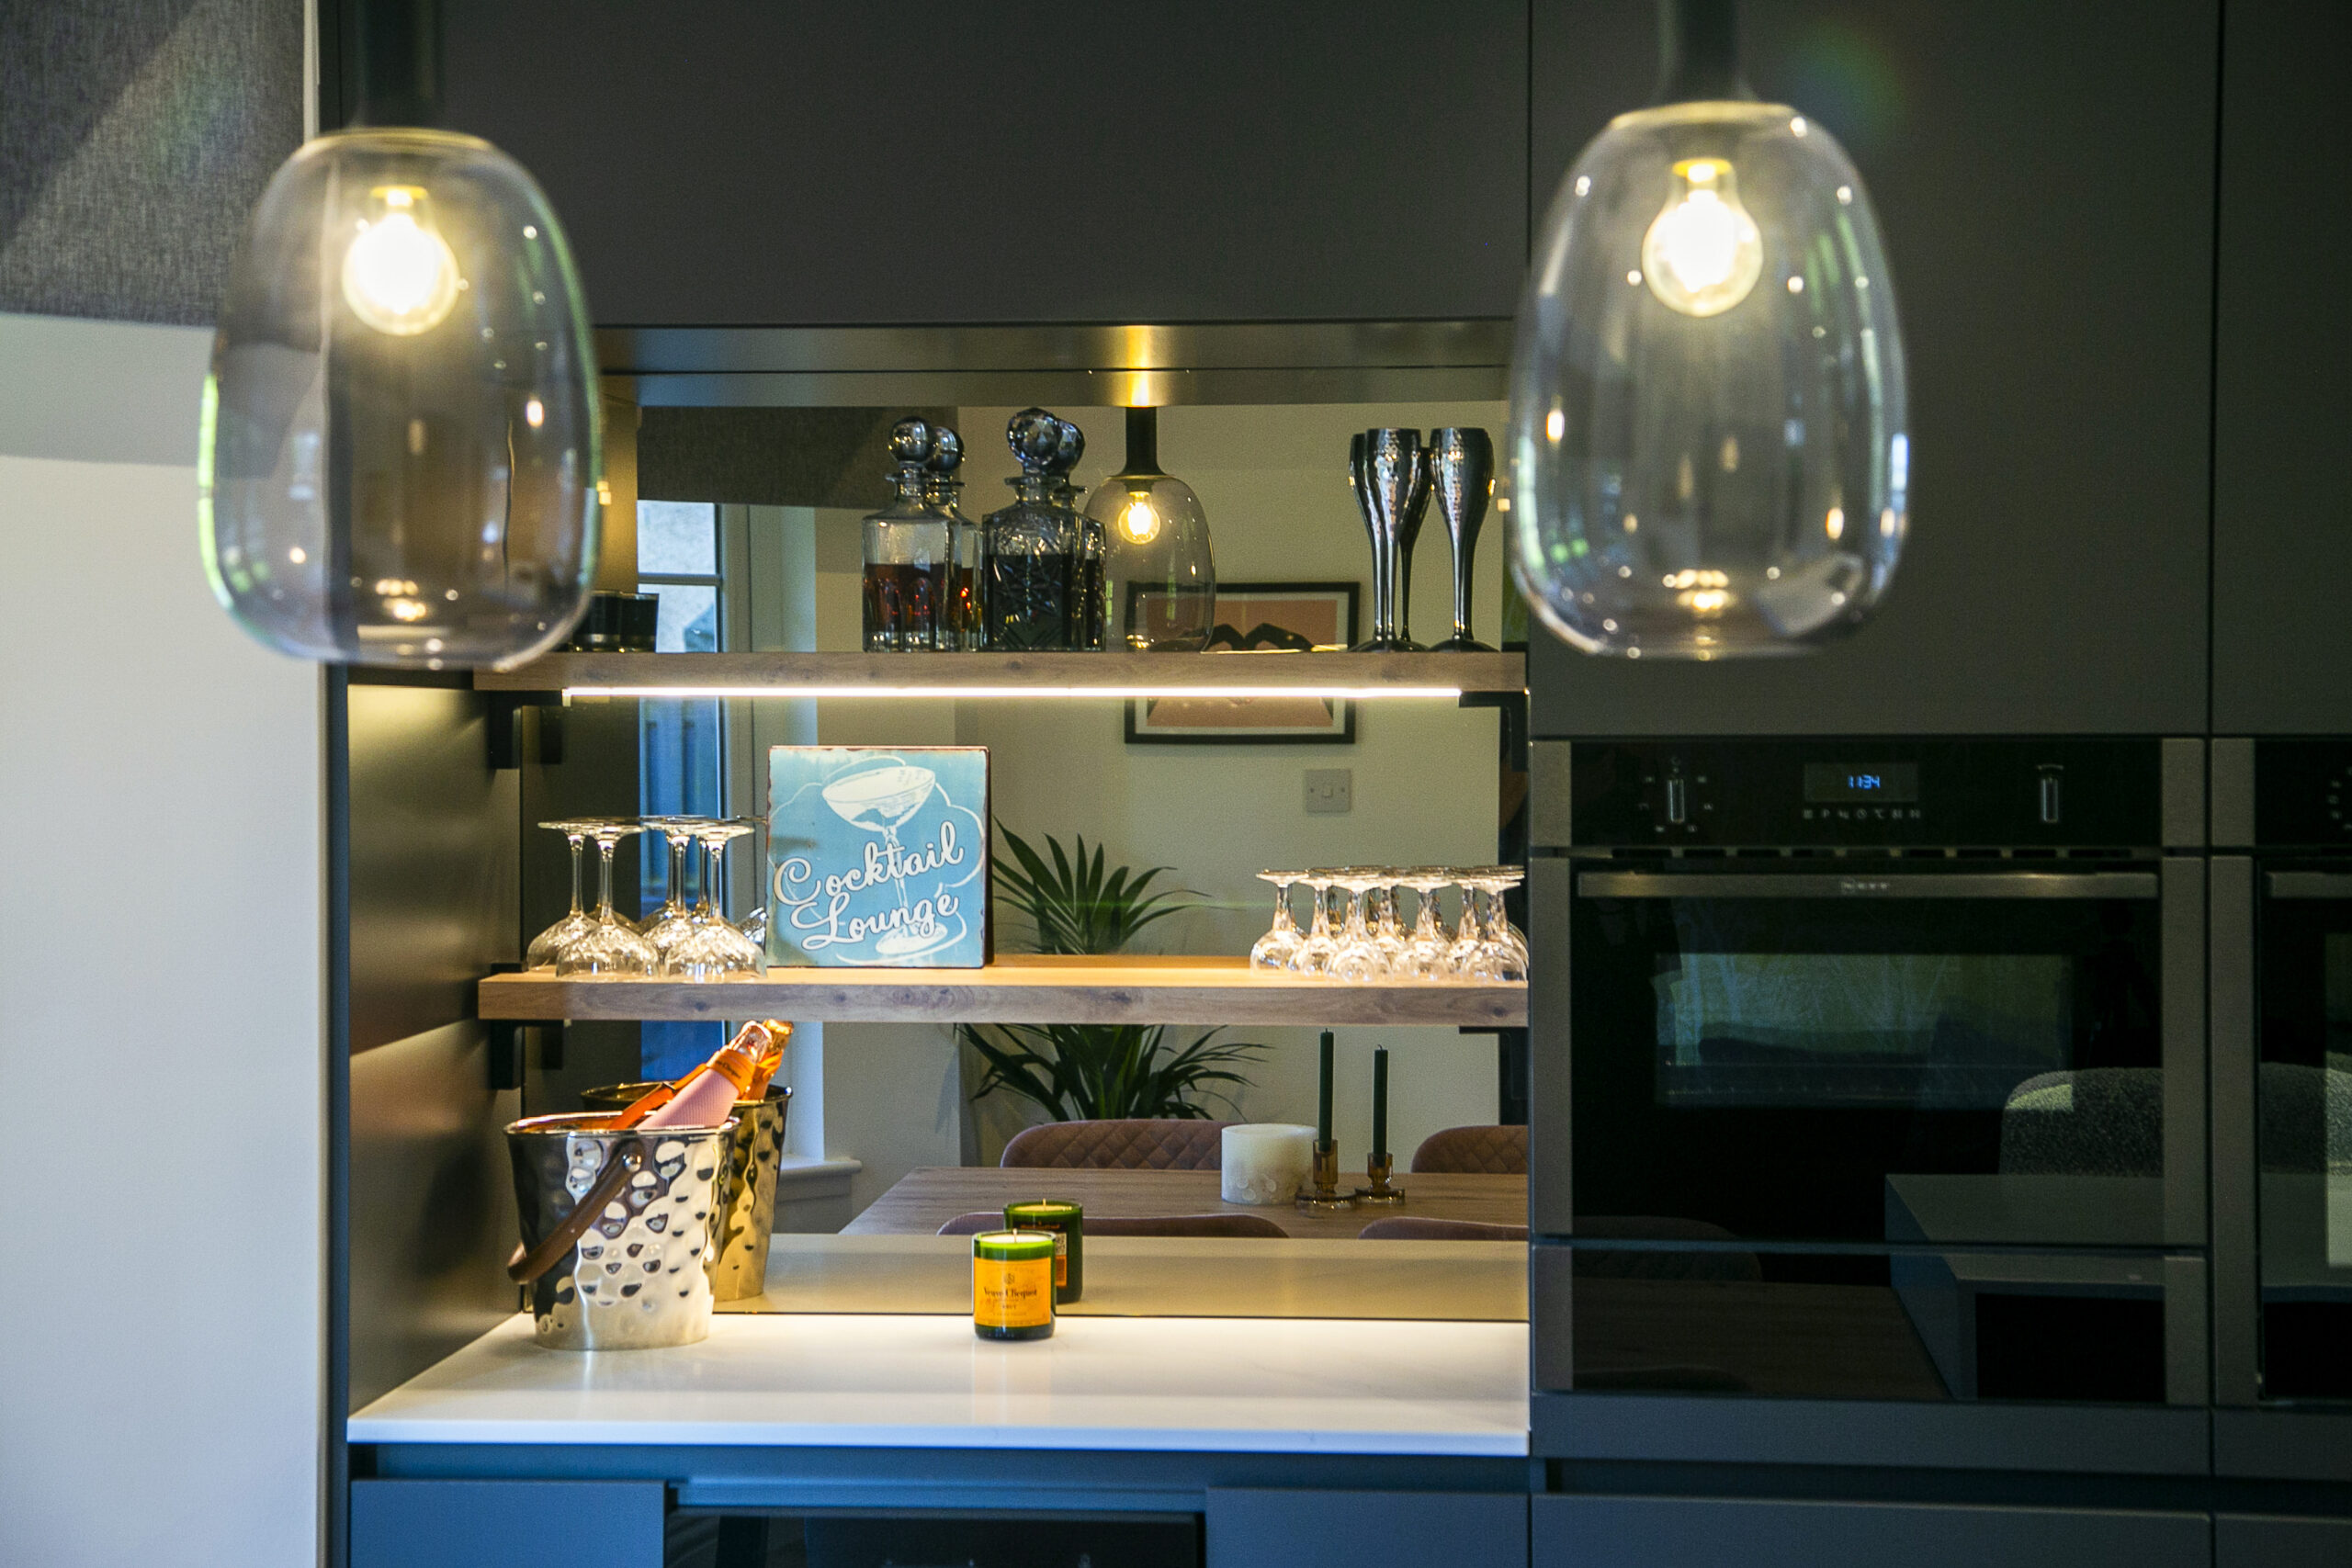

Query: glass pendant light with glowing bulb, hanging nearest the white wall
[198,0,600,670]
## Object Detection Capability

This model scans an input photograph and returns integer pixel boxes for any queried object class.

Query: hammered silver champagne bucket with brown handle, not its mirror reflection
[505,1112,736,1349]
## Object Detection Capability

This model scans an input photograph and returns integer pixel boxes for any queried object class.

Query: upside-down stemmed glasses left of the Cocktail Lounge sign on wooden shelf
[525,816,767,980]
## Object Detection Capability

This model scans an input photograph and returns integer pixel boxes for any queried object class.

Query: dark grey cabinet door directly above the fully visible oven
[1532,0,2220,736]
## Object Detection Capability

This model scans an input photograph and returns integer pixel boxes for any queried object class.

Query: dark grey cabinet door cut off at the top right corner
[2213,0,2352,733]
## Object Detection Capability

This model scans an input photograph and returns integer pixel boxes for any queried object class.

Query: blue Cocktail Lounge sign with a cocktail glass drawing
[767,745,992,968]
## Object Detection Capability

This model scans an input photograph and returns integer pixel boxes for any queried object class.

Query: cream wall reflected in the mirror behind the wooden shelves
[790,402,1503,1208]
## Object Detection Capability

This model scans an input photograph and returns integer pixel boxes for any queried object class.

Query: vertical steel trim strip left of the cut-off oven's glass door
[2206,856,2263,1405]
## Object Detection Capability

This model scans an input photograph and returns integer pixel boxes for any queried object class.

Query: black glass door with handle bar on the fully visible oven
[1569,865,2164,1246]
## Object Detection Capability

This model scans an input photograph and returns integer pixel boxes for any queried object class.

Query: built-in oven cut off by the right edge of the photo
[2213,739,2352,1408]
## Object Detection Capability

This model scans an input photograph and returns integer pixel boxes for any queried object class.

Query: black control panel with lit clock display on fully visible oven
[1569,736,2154,849]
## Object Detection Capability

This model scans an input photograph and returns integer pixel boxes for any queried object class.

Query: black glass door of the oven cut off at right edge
[2256,865,2352,1401]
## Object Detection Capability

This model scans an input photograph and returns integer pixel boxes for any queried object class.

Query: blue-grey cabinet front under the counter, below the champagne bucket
[350,1481,663,1568]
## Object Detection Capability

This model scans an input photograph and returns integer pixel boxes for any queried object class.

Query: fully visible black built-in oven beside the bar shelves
[1529,739,2206,1404]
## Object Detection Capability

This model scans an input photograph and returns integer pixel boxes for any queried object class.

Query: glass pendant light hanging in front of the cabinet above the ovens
[1508,0,1910,659]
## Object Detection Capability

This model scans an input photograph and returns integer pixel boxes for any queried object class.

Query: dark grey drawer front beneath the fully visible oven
[1532,1497,2213,1568]
